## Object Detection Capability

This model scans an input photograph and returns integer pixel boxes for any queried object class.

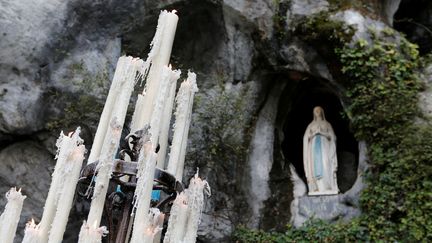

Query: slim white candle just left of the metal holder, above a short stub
[79,117,122,234]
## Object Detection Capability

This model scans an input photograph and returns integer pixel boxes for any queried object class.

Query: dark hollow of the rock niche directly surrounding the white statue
[279,77,358,193]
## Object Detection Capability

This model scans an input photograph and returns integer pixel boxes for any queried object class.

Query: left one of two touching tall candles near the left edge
[39,127,81,242]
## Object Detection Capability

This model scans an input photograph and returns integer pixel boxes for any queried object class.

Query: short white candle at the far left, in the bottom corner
[0,187,26,243]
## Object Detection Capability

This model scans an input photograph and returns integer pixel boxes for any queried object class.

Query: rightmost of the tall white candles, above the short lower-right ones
[167,72,198,180]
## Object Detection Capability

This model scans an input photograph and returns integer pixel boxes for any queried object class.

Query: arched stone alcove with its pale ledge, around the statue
[259,72,359,231]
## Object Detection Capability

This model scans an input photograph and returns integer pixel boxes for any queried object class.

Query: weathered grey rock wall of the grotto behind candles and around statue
[0,0,416,242]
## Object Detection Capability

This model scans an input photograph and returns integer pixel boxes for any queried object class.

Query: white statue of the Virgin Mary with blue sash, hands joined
[303,106,339,195]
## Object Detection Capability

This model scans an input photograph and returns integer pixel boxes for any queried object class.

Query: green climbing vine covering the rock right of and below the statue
[234,10,432,242]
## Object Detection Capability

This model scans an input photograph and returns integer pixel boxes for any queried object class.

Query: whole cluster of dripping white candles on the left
[0,11,210,243]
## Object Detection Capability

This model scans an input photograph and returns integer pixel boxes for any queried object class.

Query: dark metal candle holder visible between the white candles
[77,126,184,243]
